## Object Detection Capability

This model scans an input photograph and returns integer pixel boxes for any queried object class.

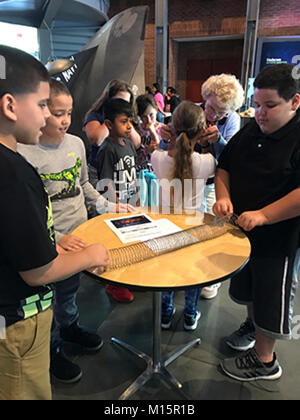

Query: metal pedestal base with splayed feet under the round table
[111,292,201,400]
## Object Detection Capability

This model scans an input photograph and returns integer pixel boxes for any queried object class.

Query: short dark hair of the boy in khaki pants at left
[0,45,50,98]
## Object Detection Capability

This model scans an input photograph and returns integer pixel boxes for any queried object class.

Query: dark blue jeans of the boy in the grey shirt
[51,273,80,350]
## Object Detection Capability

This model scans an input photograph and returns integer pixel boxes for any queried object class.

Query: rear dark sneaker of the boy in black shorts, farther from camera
[226,318,255,351]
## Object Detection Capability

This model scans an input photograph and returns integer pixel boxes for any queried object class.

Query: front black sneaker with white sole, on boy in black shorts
[220,349,282,382]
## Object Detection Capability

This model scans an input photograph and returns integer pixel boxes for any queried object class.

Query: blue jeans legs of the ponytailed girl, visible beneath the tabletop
[161,289,201,316]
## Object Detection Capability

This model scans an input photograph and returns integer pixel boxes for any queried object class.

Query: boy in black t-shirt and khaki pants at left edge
[0,45,108,400]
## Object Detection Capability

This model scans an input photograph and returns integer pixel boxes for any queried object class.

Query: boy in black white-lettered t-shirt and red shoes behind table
[97,98,138,302]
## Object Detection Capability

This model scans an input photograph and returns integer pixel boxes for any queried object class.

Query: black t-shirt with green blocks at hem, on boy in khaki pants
[0,144,57,327]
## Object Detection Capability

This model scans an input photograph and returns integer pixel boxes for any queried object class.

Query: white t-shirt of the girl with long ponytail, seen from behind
[151,150,216,211]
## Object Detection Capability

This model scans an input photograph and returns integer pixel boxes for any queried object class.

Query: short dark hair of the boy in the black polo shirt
[254,63,300,101]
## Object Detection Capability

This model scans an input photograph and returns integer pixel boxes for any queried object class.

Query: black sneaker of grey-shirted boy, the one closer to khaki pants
[50,348,82,384]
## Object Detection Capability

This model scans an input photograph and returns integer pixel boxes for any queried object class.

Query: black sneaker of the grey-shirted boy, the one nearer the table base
[60,322,103,351]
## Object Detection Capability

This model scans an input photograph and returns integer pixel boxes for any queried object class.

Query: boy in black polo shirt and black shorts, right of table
[213,64,300,381]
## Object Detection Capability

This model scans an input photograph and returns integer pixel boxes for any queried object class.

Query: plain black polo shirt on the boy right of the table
[218,111,300,256]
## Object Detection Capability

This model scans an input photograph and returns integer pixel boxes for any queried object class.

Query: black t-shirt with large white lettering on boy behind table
[97,137,137,205]
